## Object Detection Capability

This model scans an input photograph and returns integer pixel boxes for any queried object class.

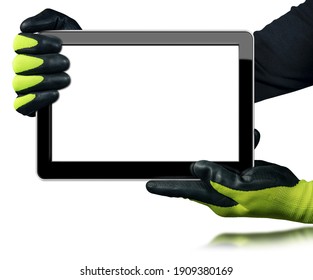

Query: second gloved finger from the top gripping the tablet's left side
[13,54,70,75]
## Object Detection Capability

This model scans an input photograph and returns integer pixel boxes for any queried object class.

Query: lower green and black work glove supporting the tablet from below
[146,131,313,223]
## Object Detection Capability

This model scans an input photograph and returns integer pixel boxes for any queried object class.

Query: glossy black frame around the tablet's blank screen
[37,31,254,179]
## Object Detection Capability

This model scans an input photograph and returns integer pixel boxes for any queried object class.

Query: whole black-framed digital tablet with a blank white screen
[37,31,254,179]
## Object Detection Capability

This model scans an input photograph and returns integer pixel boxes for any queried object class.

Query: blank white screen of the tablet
[52,46,239,161]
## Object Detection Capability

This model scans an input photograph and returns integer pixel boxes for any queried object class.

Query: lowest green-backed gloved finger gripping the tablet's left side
[14,90,59,116]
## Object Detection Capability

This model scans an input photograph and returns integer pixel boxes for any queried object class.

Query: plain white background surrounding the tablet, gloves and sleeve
[0,0,313,280]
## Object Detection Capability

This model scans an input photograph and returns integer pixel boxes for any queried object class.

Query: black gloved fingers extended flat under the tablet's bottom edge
[146,180,237,207]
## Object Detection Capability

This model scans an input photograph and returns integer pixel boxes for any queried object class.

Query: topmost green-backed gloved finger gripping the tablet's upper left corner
[13,33,62,54]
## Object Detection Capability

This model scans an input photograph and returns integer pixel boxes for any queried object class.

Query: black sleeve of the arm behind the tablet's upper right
[254,0,313,102]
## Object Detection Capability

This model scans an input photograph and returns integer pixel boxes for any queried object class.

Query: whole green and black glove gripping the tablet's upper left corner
[13,9,81,116]
